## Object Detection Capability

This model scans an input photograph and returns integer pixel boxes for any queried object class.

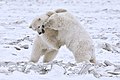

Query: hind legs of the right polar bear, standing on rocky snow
[68,41,96,63]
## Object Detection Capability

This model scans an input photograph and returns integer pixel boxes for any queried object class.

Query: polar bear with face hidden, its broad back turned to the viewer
[45,12,95,62]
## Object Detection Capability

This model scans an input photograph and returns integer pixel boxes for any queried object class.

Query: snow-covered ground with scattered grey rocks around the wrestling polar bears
[0,0,120,80]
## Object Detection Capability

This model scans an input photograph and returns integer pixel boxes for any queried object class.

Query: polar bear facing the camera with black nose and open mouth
[29,9,66,62]
